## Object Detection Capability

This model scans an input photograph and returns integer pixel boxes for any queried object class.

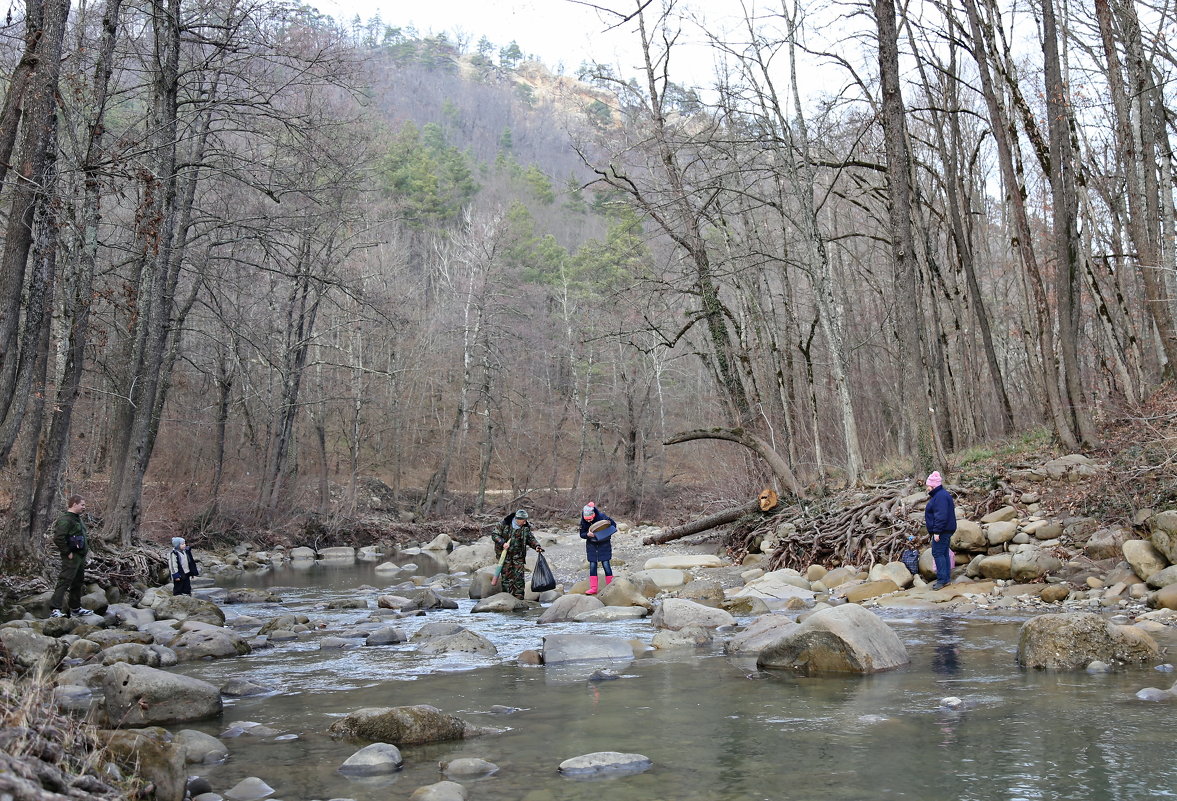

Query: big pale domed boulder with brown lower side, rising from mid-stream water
[756,603,911,675]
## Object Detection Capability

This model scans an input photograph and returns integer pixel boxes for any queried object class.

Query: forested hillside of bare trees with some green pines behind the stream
[0,0,1177,563]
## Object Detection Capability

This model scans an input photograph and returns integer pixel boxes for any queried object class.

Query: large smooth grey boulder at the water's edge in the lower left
[102,663,221,726]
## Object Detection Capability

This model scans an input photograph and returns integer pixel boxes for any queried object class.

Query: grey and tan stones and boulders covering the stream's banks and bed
[0,460,1177,801]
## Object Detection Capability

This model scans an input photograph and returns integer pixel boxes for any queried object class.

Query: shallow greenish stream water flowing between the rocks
[175,559,1177,801]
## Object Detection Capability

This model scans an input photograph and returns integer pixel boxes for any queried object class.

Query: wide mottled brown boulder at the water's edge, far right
[1017,612,1161,670]
